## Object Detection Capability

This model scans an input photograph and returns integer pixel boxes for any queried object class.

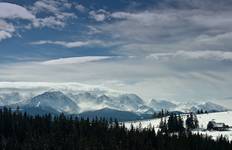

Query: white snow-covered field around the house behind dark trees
[125,111,232,141]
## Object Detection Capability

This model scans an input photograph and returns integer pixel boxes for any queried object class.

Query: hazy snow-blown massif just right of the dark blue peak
[70,92,154,114]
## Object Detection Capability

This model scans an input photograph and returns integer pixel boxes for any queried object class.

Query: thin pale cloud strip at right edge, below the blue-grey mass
[147,50,232,61]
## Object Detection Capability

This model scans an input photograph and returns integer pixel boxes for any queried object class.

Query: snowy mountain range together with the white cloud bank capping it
[0,83,227,120]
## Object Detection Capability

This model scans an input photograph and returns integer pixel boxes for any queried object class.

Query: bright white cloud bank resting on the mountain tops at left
[0,82,120,98]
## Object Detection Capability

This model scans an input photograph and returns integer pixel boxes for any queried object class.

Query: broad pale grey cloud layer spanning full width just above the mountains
[0,56,232,101]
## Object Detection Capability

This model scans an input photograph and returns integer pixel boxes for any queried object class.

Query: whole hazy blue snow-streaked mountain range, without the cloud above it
[0,90,227,115]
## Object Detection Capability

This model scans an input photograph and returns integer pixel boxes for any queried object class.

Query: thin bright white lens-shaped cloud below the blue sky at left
[41,56,112,65]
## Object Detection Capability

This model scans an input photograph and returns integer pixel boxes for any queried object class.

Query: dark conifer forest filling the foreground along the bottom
[0,108,232,150]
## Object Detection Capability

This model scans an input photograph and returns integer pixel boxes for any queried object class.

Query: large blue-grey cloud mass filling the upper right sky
[90,0,232,55]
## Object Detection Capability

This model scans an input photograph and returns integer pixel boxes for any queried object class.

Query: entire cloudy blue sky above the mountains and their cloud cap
[0,0,232,106]
